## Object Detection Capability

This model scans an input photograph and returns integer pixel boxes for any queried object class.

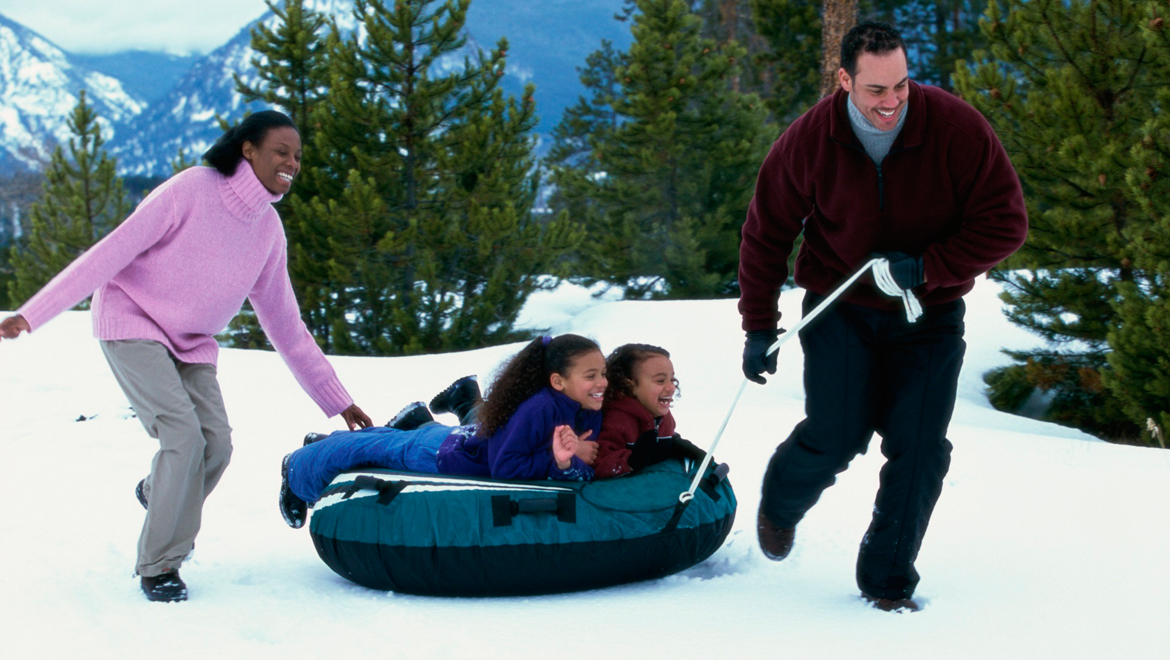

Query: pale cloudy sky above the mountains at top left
[0,0,268,55]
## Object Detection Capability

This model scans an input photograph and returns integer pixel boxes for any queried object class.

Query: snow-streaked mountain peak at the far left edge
[0,15,146,170]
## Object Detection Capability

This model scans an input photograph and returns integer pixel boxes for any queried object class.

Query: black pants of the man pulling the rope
[761,293,966,599]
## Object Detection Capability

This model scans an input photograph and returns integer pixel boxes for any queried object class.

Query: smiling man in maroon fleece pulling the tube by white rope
[739,22,1027,610]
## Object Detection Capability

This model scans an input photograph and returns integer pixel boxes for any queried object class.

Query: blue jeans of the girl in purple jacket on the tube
[288,424,453,503]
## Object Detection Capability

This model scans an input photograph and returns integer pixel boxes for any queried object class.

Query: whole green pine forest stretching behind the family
[0,0,1170,444]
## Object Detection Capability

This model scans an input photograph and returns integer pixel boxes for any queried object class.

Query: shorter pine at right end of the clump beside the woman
[429,73,581,349]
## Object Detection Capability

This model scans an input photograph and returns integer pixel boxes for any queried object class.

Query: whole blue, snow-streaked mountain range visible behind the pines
[0,0,629,176]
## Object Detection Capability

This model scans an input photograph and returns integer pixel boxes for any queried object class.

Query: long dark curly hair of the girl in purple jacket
[479,335,601,435]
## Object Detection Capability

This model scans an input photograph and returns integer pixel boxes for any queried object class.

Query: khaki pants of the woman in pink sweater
[102,339,232,577]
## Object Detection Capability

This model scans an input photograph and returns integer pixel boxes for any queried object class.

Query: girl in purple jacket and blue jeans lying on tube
[280,335,607,528]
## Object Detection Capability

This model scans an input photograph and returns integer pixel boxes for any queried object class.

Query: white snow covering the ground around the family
[0,280,1170,659]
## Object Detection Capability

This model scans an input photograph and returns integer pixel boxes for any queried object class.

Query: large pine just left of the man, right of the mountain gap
[552,0,771,297]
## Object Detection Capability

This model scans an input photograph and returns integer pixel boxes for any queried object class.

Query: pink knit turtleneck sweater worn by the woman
[18,160,353,417]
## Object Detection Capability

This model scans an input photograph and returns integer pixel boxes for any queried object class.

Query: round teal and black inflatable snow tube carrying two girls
[309,460,736,596]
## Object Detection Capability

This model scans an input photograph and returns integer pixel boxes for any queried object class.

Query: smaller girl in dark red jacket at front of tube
[593,344,704,479]
